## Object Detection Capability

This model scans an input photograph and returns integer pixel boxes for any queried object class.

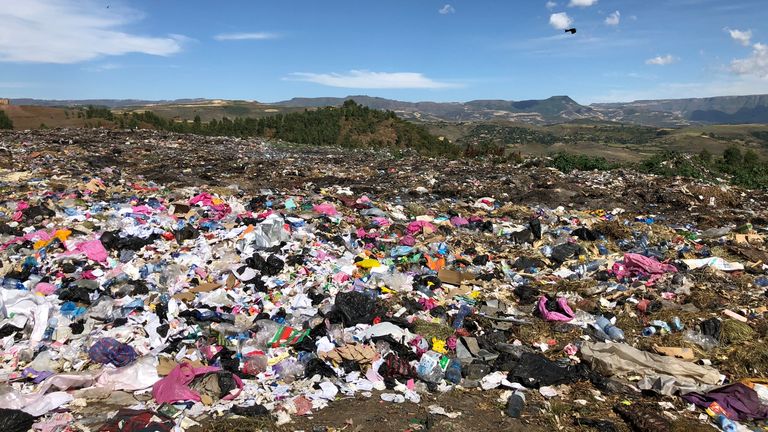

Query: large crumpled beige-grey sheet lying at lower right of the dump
[581,342,722,394]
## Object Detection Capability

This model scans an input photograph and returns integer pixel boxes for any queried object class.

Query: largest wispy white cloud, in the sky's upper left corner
[0,0,185,63]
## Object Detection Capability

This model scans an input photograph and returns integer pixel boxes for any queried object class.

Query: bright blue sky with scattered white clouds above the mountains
[0,0,768,103]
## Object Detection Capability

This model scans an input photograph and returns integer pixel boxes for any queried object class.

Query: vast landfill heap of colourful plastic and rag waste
[0,129,768,432]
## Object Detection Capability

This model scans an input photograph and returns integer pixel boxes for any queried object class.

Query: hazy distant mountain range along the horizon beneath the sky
[11,95,768,127]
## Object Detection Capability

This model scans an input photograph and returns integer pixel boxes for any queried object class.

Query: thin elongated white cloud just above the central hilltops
[285,70,460,89]
